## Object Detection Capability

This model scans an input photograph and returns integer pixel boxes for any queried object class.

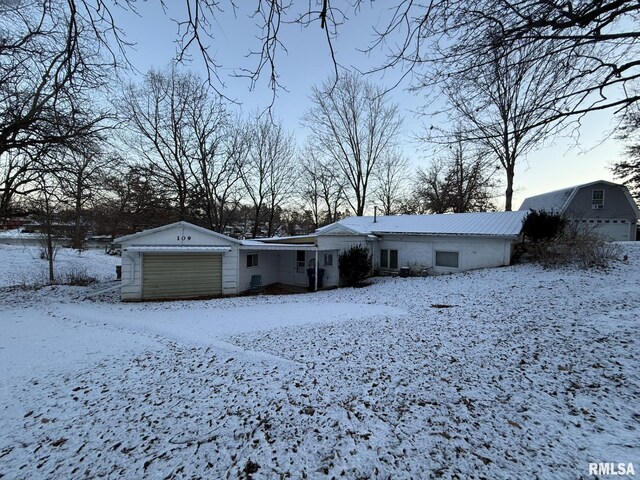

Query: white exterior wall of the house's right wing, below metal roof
[374,235,511,273]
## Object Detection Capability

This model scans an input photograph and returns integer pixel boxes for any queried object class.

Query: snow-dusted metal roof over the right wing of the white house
[317,211,527,236]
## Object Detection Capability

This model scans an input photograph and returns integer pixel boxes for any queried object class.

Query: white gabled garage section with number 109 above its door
[116,222,241,301]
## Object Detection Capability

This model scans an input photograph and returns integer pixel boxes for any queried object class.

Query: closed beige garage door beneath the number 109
[142,253,222,300]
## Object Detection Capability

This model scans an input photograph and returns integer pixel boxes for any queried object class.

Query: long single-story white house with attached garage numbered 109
[115,211,527,300]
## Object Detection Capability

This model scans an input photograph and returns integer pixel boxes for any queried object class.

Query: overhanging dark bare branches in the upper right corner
[370,0,640,124]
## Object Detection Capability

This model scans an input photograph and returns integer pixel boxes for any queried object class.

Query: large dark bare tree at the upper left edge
[0,1,110,218]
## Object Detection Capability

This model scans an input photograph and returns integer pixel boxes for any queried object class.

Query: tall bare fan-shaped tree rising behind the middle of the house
[304,73,402,216]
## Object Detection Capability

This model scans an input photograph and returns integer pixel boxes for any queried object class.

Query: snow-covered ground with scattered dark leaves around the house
[0,246,640,479]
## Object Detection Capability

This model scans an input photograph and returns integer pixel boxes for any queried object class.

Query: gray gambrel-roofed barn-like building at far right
[520,180,640,241]
